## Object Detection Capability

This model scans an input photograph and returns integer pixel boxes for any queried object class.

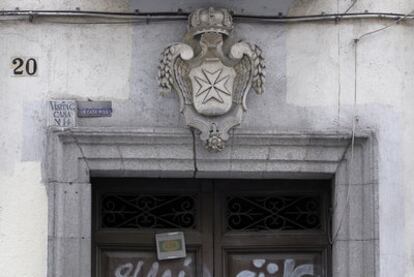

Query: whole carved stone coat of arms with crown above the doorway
[158,8,265,152]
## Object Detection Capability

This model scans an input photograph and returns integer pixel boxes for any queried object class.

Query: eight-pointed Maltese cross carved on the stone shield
[194,69,231,104]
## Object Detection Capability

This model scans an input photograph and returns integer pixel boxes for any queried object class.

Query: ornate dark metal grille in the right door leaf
[226,195,321,231]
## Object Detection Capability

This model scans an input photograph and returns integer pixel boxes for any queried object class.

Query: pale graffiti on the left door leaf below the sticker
[114,257,193,277]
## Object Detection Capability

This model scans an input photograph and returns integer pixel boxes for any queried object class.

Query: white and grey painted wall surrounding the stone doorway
[0,0,414,277]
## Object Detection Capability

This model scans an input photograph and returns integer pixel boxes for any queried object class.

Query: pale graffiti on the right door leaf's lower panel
[236,259,318,277]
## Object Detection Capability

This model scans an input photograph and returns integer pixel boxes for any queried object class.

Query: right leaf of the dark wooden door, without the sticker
[214,180,330,277]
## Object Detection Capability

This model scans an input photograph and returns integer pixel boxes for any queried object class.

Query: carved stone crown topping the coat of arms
[188,7,233,36]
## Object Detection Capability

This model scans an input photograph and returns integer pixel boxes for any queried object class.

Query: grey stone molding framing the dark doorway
[46,127,379,277]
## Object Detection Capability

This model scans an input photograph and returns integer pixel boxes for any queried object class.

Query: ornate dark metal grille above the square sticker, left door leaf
[100,194,197,229]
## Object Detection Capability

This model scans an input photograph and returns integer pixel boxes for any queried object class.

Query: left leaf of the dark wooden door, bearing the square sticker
[93,179,213,277]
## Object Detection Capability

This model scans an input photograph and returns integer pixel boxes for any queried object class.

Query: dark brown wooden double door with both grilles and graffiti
[92,178,330,277]
